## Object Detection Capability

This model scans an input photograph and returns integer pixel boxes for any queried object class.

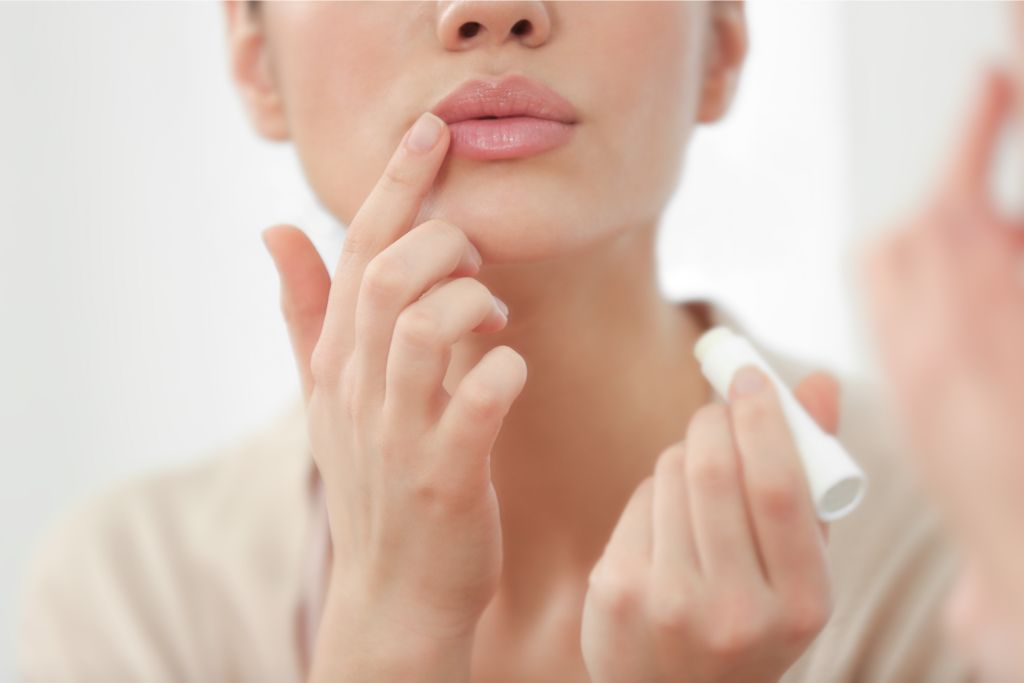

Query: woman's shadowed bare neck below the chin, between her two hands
[444,225,711,618]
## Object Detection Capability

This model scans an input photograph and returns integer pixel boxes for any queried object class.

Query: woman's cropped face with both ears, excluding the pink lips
[227,1,745,263]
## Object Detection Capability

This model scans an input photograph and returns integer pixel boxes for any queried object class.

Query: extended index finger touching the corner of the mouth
[322,112,451,354]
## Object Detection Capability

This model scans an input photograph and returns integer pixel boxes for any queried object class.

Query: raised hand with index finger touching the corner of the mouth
[263,114,526,680]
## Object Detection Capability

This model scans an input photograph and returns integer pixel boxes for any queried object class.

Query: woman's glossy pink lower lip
[449,116,574,161]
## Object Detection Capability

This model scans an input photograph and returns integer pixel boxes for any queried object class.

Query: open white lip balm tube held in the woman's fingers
[693,327,867,522]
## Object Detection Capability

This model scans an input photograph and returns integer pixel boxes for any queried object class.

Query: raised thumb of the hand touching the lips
[260,225,331,402]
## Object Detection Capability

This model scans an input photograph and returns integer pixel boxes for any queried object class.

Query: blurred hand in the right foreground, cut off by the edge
[864,30,1024,682]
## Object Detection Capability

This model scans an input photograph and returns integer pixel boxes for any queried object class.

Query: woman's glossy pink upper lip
[430,75,575,124]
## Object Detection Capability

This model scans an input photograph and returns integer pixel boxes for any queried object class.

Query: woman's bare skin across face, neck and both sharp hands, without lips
[226,2,838,683]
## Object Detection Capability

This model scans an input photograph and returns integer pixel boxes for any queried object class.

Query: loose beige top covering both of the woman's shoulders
[17,309,969,683]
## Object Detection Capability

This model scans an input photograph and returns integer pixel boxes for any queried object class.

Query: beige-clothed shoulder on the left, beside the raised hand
[17,401,307,681]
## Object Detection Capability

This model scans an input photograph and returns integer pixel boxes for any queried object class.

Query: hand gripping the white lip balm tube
[582,368,839,683]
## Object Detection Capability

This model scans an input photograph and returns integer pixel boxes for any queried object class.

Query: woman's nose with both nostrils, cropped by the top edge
[437,0,551,51]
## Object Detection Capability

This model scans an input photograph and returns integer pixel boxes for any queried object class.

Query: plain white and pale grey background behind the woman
[0,3,1010,680]
